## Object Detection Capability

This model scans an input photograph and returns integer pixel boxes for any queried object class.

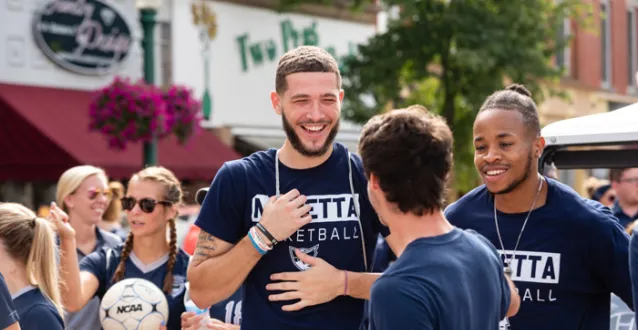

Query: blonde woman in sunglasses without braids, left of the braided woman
[56,165,122,330]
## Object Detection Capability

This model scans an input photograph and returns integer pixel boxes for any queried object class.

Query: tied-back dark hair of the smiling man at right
[479,84,541,137]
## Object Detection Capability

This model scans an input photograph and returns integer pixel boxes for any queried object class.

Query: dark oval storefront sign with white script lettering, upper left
[33,0,133,75]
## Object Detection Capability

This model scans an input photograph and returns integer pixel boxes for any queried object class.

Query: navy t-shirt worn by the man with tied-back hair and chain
[445,179,633,330]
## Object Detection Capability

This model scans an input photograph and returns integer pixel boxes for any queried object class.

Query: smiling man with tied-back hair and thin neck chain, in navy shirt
[445,85,633,330]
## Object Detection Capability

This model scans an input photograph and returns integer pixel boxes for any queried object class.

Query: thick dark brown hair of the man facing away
[359,105,454,216]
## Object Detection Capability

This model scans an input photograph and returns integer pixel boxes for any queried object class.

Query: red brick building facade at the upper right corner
[540,0,638,193]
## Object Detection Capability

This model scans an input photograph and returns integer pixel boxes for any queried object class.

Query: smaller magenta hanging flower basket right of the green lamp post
[163,86,203,145]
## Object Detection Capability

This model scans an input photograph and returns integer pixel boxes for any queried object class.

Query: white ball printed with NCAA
[100,278,168,330]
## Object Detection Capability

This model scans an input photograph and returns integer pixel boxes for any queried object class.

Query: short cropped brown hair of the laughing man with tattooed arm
[275,46,341,94]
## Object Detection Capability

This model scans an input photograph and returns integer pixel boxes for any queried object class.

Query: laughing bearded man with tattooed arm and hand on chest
[188,46,387,330]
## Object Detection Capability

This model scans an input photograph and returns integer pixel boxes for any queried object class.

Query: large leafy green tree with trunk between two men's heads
[340,0,590,196]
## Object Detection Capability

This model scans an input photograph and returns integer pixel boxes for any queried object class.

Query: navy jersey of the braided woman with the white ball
[80,245,189,330]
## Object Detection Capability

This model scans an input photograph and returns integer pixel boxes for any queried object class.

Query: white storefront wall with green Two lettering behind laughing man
[171,0,376,129]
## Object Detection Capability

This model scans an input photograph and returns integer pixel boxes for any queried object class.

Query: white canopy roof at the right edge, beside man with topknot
[541,103,638,146]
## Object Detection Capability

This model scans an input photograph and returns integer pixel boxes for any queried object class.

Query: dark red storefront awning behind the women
[0,84,240,181]
